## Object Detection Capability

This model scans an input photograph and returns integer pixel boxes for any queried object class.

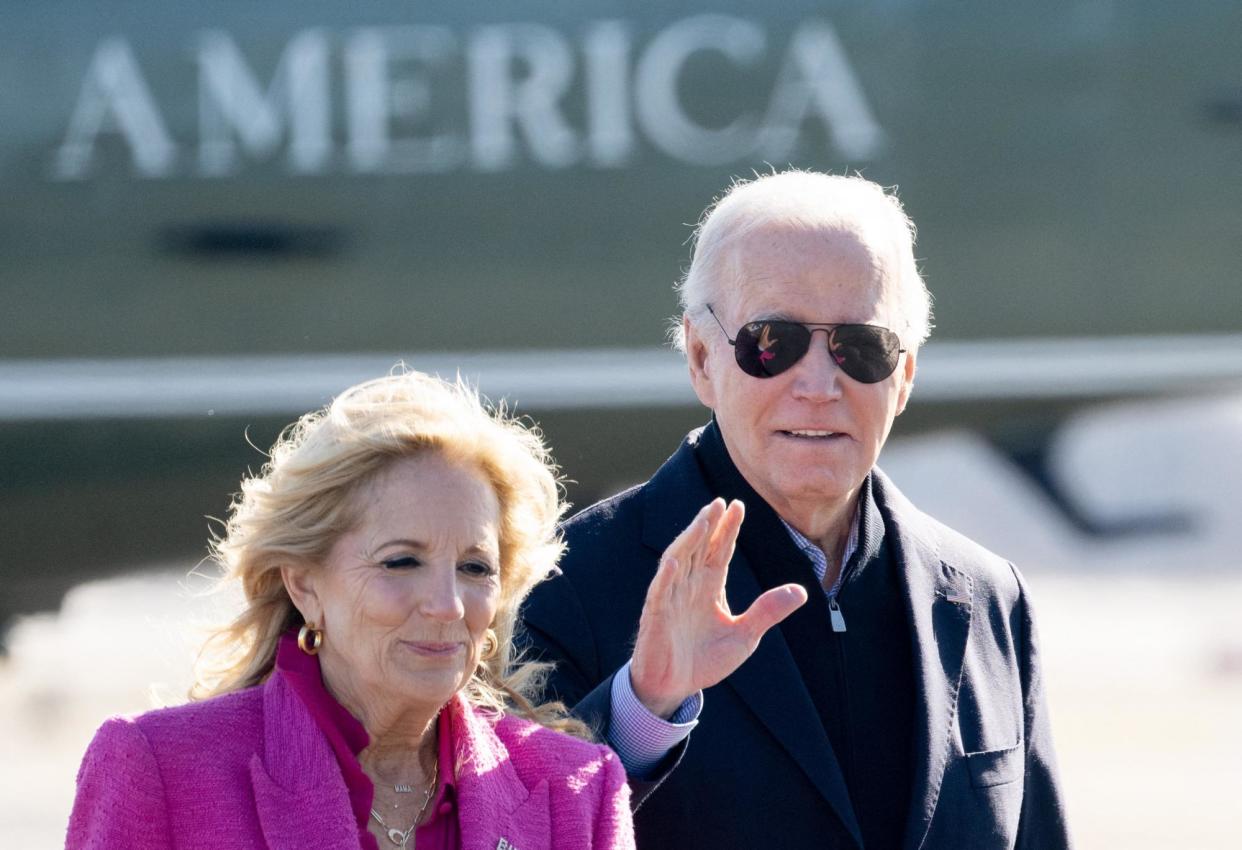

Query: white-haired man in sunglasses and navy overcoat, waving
[525,171,1068,850]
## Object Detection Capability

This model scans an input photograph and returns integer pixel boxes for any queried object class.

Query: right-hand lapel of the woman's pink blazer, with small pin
[448,695,551,850]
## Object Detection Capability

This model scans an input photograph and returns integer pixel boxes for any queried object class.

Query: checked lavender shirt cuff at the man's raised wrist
[609,661,703,779]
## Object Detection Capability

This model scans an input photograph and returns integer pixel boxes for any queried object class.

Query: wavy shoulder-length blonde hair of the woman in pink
[190,372,587,736]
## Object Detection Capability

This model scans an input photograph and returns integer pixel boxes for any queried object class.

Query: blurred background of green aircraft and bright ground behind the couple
[0,0,1242,849]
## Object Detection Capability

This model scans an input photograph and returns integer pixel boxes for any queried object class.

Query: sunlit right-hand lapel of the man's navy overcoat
[873,470,974,850]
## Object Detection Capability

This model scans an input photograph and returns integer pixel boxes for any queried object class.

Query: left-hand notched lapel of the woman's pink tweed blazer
[250,675,359,850]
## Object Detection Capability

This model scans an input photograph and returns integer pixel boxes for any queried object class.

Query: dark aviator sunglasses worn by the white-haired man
[707,304,905,384]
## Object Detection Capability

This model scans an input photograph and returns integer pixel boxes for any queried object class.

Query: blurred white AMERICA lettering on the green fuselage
[51,15,884,180]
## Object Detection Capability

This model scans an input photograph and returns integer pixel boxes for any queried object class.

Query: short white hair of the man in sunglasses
[669,169,932,350]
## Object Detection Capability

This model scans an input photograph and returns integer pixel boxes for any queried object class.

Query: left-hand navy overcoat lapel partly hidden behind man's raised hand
[643,439,862,846]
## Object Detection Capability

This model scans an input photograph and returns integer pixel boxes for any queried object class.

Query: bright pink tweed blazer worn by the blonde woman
[66,672,633,850]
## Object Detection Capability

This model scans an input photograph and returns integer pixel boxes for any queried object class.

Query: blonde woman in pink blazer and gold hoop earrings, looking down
[68,373,633,850]
